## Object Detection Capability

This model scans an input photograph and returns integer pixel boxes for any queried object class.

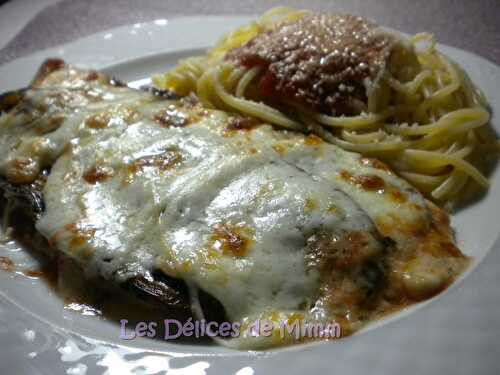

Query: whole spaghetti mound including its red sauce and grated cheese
[153,8,497,203]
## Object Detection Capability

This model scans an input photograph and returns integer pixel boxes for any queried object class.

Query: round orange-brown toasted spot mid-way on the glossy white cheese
[211,224,252,258]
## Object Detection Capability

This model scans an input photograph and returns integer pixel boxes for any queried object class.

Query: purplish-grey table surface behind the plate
[0,0,500,65]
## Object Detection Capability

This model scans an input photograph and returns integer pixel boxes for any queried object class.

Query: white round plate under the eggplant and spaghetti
[0,17,500,375]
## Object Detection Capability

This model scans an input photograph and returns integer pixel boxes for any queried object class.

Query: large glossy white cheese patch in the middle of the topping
[38,106,375,319]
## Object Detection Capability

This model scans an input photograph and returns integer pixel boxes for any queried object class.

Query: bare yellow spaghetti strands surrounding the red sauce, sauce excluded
[154,7,492,202]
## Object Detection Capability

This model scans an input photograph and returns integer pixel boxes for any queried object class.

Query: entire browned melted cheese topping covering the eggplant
[0,64,464,347]
